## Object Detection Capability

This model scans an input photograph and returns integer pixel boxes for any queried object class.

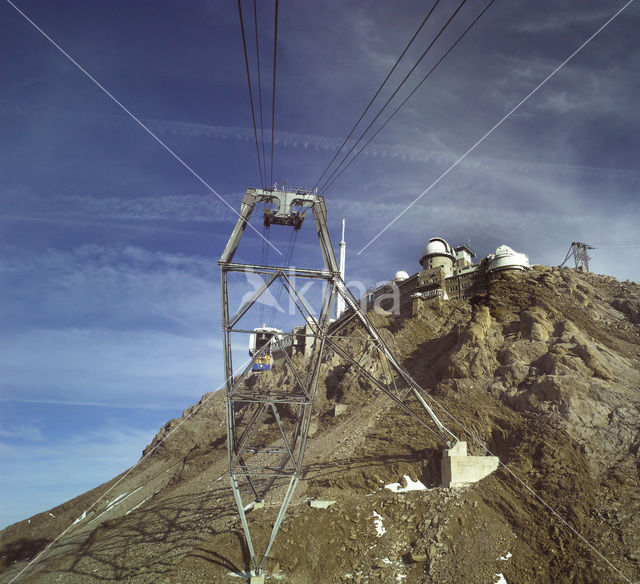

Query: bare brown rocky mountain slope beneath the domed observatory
[0,267,640,584]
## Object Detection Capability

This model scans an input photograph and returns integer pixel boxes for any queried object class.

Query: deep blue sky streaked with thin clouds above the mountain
[0,0,640,527]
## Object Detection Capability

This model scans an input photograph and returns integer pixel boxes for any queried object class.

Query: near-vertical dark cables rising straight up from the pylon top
[238,0,278,188]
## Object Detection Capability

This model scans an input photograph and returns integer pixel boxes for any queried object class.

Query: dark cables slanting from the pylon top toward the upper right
[316,0,495,192]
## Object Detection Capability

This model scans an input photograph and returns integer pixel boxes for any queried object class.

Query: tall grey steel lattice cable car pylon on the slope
[218,188,458,582]
